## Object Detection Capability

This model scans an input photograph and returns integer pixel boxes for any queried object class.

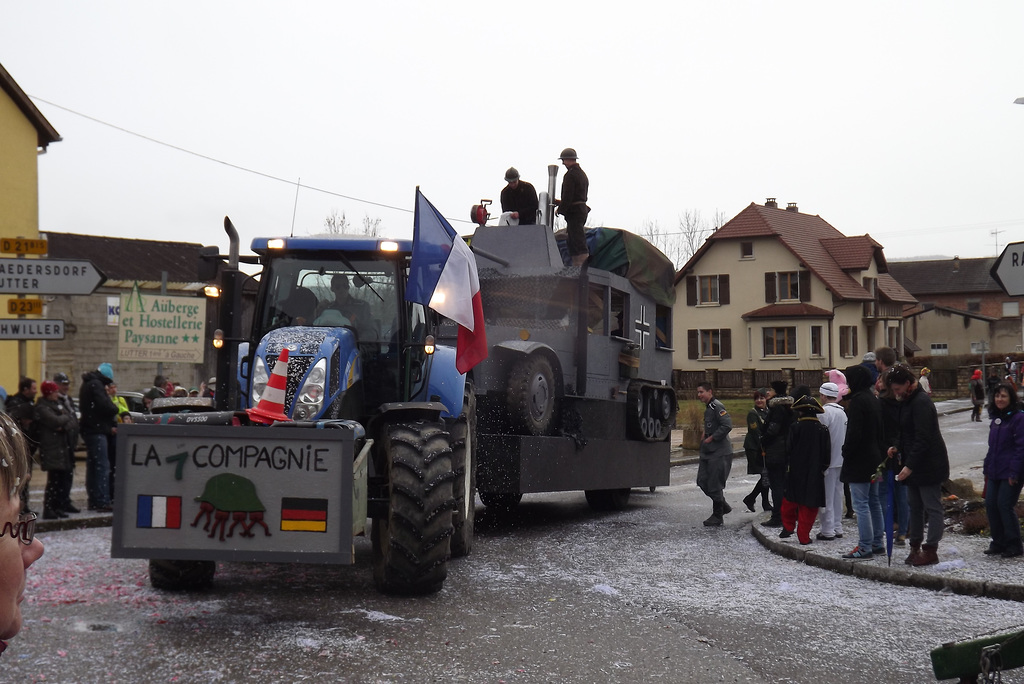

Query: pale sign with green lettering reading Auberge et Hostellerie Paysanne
[118,283,206,364]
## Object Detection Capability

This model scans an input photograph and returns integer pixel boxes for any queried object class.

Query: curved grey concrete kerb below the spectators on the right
[751,523,1024,602]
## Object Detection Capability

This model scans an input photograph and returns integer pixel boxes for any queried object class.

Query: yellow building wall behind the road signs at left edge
[0,91,44,394]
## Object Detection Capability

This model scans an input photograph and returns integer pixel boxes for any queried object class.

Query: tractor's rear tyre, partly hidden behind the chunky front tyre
[452,380,476,558]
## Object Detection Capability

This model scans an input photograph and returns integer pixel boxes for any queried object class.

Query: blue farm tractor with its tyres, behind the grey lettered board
[119,228,476,594]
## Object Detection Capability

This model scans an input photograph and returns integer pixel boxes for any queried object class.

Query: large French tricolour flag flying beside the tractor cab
[406,187,487,373]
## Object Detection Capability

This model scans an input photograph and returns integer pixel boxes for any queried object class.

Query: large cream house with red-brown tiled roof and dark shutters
[673,199,914,386]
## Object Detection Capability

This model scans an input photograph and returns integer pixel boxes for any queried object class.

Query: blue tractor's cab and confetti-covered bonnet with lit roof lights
[245,238,446,422]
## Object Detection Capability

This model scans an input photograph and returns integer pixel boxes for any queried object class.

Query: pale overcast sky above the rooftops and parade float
[0,0,1024,259]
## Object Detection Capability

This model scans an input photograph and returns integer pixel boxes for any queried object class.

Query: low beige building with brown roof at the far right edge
[889,257,1024,357]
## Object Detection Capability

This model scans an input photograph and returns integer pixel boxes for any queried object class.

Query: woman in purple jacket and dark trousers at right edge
[984,383,1024,558]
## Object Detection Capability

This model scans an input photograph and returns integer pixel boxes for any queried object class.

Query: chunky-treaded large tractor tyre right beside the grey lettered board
[373,421,455,594]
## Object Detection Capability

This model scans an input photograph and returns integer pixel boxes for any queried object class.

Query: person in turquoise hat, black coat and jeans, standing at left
[78,364,118,513]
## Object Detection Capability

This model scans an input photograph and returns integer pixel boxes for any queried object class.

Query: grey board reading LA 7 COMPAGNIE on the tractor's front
[111,423,354,563]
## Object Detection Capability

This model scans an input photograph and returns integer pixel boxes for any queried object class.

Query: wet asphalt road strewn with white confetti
[2,409,1024,683]
